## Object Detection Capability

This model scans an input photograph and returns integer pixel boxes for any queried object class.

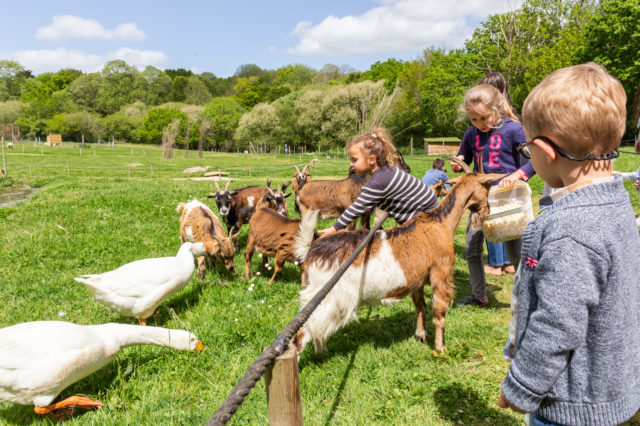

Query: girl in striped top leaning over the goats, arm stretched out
[318,129,438,236]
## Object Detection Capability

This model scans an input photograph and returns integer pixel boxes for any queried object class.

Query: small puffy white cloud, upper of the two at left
[35,15,146,43]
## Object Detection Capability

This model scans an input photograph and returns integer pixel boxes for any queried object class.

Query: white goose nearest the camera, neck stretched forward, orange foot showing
[0,321,203,418]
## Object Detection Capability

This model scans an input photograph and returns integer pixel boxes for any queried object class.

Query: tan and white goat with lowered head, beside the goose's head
[176,198,239,279]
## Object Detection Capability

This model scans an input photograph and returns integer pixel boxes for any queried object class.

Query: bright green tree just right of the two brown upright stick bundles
[201,97,245,150]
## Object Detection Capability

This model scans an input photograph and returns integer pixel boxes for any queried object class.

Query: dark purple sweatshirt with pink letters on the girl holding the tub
[458,118,535,181]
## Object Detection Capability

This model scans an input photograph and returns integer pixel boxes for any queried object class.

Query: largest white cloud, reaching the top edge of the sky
[287,0,521,56]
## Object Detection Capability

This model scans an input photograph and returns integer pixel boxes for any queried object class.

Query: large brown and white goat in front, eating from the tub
[293,169,504,353]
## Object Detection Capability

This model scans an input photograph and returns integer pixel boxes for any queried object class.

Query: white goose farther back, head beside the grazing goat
[75,242,206,325]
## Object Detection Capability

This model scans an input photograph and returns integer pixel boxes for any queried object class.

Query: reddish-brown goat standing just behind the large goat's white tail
[244,208,318,285]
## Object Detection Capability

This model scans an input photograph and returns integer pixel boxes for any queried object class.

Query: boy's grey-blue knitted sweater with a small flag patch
[502,177,640,425]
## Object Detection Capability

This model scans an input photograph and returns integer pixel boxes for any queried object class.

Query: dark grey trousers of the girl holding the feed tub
[465,222,522,299]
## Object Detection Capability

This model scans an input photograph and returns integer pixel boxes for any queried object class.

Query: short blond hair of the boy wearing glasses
[522,62,627,157]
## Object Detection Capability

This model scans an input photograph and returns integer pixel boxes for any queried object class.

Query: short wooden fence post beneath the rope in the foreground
[264,346,302,426]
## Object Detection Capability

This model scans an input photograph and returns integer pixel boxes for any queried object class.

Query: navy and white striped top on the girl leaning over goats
[333,167,438,230]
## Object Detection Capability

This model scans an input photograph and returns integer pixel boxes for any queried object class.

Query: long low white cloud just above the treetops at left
[7,47,167,74]
